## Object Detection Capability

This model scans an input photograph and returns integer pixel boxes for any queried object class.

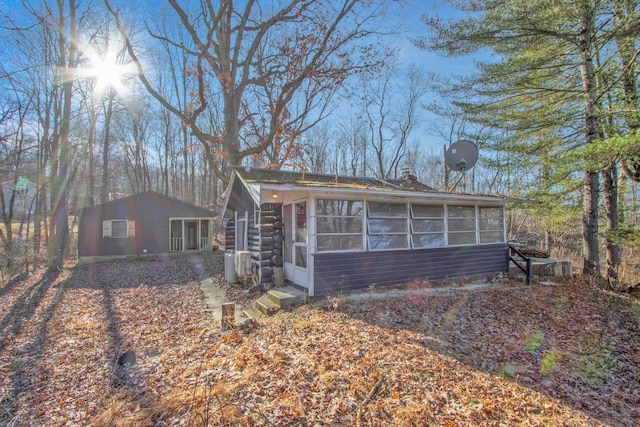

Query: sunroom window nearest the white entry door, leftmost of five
[316,199,363,252]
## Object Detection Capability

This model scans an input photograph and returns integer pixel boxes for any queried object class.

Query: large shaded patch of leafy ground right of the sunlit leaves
[328,282,640,426]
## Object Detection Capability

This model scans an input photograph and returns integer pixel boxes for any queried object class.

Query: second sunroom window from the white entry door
[367,202,409,251]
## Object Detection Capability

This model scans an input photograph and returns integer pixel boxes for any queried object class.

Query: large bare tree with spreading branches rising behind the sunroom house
[107,0,386,180]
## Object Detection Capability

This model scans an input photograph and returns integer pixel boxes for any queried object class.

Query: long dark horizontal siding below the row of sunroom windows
[314,244,507,295]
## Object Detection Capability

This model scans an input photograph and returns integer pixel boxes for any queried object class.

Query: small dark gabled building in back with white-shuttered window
[78,191,215,262]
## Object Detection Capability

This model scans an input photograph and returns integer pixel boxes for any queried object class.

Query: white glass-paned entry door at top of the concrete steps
[282,201,308,287]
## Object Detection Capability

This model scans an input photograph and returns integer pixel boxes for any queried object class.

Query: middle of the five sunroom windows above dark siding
[411,204,445,249]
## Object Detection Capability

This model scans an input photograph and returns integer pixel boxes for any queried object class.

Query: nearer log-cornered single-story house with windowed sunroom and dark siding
[223,167,508,296]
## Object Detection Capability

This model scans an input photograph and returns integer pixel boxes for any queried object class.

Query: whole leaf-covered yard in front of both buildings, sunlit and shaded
[0,253,640,426]
